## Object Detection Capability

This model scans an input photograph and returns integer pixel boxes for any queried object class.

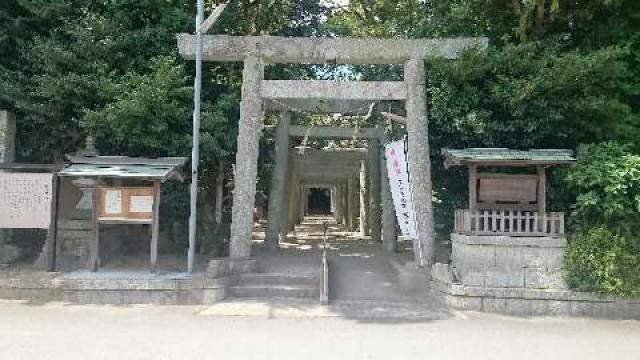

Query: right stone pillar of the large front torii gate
[404,59,435,268]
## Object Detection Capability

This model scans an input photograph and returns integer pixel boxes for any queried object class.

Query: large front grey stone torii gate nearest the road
[178,34,488,266]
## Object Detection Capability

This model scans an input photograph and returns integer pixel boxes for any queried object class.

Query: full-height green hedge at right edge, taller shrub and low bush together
[564,142,640,296]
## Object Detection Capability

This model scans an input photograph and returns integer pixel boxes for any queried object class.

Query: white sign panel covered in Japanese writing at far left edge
[0,172,53,229]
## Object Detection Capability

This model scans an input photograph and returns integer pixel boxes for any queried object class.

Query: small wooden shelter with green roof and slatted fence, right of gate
[442,148,576,236]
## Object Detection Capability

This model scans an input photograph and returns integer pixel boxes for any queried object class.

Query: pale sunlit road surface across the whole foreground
[0,301,640,360]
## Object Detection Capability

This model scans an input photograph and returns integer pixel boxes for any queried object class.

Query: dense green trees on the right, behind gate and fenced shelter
[327,0,640,237]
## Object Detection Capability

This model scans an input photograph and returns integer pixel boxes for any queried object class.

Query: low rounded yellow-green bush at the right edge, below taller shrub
[565,226,640,297]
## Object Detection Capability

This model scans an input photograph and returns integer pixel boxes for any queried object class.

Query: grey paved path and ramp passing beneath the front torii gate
[254,216,440,305]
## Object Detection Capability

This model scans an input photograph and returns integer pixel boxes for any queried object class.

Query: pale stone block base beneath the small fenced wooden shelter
[451,234,567,289]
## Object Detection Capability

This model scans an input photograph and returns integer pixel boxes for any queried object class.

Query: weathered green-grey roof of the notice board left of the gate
[59,156,186,181]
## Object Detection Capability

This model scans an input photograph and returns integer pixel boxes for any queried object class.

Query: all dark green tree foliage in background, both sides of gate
[0,0,640,258]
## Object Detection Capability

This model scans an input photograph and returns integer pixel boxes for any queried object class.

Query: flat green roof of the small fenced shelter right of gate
[442,148,576,167]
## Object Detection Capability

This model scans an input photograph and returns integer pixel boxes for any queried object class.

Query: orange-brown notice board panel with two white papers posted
[99,186,157,223]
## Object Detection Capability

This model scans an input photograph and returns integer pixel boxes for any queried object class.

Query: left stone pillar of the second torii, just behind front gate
[265,111,291,249]
